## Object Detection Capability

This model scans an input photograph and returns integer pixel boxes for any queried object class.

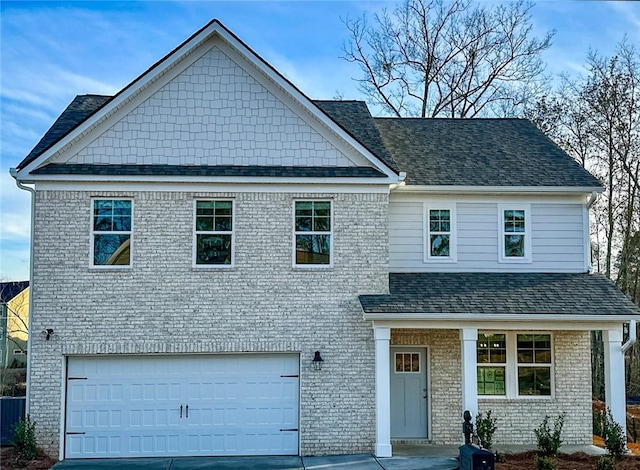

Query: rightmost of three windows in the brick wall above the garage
[295,201,332,266]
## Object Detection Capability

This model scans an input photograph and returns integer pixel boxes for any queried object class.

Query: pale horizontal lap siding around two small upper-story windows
[389,199,585,272]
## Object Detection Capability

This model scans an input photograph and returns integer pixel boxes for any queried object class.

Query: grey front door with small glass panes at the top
[390,347,428,439]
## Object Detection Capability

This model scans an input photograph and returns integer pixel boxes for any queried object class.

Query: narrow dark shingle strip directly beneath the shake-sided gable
[32,163,385,178]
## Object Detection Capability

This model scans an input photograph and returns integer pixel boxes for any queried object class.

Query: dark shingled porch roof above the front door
[360,273,640,319]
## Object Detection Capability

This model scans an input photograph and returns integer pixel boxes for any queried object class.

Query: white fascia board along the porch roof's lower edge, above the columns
[364,312,640,329]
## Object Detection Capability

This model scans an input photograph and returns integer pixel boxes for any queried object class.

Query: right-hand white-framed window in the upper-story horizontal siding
[499,205,531,263]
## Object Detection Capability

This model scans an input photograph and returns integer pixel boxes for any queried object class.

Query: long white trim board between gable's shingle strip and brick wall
[35,179,389,194]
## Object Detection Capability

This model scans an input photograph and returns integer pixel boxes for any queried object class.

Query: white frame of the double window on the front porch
[476,330,556,400]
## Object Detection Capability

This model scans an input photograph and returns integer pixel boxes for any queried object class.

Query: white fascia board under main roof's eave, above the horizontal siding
[394,184,603,195]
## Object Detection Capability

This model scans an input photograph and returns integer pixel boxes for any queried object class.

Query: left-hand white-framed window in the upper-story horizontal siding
[424,204,456,262]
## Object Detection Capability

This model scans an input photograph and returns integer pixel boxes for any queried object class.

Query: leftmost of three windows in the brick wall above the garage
[91,199,133,267]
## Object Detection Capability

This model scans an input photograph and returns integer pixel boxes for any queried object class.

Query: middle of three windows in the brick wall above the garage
[194,200,233,267]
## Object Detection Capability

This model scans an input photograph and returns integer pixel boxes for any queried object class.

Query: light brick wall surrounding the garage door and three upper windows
[30,191,388,456]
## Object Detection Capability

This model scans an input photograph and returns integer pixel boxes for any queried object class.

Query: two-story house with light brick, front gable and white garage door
[14,20,640,458]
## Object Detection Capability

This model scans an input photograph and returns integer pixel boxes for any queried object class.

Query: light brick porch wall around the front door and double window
[391,330,591,445]
